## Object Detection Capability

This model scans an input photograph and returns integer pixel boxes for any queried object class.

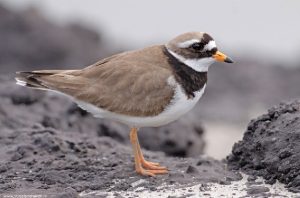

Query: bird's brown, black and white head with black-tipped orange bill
[165,32,233,71]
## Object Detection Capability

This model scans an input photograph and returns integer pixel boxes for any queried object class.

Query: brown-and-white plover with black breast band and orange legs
[15,32,233,176]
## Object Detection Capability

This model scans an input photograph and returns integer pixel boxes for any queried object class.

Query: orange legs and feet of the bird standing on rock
[130,128,168,176]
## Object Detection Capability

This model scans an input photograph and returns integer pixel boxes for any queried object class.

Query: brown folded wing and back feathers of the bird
[19,46,174,116]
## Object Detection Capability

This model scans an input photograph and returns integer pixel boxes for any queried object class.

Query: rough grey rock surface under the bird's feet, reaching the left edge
[0,79,240,195]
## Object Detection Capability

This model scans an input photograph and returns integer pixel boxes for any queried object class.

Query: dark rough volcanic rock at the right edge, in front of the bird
[227,101,300,192]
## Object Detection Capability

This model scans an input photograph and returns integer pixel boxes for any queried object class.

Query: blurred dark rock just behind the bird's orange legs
[139,120,205,157]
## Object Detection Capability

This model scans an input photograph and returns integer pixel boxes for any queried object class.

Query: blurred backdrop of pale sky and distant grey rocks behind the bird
[0,0,300,159]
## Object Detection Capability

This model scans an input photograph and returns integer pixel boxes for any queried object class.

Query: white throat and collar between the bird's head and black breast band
[167,48,215,72]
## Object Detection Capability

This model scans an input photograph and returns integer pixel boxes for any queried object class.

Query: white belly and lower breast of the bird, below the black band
[77,84,206,128]
